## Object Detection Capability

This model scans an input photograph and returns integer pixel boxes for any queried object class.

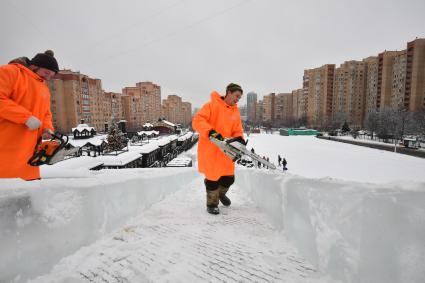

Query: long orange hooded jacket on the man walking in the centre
[192,91,243,181]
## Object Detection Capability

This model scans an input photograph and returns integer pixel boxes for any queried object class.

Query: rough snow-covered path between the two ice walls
[30,179,332,283]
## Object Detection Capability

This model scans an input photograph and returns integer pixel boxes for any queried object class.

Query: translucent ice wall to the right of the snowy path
[237,169,425,283]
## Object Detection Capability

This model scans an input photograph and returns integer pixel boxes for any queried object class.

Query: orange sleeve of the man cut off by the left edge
[0,65,32,124]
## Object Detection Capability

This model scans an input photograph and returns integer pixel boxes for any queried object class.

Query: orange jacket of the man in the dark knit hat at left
[0,64,54,180]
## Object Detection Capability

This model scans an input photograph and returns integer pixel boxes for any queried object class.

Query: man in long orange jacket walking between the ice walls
[192,83,245,214]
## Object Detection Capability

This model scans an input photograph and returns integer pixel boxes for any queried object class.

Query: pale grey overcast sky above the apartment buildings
[0,0,425,107]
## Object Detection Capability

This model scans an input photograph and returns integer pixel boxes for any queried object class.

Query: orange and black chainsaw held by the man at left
[28,132,80,166]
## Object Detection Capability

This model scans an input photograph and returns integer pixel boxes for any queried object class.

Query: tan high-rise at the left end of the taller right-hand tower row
[303,64,335,126]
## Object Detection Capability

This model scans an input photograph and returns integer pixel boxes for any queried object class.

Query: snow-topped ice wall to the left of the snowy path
[0,168,199,282]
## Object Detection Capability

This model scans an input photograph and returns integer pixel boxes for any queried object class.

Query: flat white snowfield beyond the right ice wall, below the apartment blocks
[247,134,425,183]
